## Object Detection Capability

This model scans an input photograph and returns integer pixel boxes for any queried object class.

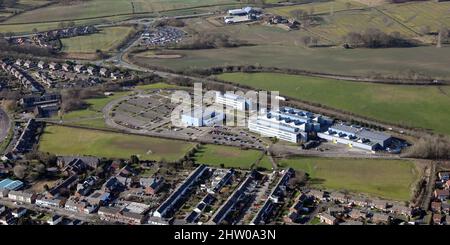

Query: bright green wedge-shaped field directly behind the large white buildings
[218,73,450,134]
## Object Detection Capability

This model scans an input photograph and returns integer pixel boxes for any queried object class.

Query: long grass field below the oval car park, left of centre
[39,126,194,161]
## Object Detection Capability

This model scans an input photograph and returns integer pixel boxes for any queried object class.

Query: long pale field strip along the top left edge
[0,0,238,33]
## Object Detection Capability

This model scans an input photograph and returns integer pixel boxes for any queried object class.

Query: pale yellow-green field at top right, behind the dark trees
[268,0,450,43]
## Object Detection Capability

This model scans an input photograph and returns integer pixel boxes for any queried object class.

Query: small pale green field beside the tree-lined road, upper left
[61,26,135,53]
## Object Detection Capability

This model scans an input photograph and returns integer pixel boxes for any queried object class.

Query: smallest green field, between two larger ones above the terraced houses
[195,145,262,169]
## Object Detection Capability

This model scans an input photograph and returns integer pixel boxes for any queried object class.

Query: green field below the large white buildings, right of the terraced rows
[280,157,419,201]
